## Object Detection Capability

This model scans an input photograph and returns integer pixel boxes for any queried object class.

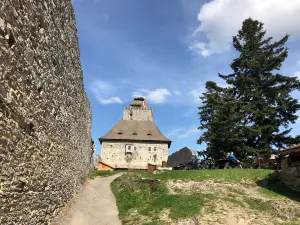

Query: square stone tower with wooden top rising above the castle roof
[123,97,154,122]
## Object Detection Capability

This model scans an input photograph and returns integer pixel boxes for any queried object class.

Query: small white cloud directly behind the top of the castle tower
[133,88,171,104]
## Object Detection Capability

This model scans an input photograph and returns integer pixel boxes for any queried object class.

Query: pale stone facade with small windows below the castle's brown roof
[101,141,169,169]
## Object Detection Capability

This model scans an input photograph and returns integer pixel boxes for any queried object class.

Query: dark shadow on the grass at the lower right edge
[257,174,300,202]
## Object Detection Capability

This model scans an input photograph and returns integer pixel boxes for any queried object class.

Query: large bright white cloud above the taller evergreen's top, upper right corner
[190,0,300,56]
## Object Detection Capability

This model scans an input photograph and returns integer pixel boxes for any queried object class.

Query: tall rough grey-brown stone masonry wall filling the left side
[0,0,91,225]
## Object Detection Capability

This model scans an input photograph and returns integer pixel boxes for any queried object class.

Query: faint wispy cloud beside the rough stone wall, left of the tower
[89,80,123,105]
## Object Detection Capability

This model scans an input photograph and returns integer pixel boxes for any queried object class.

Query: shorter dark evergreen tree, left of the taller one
[198,81,242,159]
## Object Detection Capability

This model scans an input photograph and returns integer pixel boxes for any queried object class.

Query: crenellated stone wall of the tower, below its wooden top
[123,107,153,121]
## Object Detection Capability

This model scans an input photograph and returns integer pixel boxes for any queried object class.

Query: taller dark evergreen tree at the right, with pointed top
[219,18,300,155]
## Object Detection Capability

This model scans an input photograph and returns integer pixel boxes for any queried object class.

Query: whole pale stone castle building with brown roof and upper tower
[99,97,171,169]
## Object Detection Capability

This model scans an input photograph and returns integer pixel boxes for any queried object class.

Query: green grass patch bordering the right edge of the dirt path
[111,173,216,224]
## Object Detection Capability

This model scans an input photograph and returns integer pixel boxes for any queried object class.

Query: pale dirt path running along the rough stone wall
[54,174,121,225]
